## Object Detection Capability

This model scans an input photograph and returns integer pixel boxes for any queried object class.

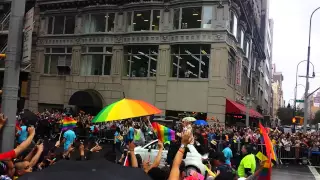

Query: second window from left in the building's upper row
[83,13,115,33]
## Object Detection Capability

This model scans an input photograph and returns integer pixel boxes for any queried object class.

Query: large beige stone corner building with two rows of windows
[26,0,265,122]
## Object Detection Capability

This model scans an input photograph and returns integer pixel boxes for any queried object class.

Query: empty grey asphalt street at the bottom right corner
[272,166,316,180]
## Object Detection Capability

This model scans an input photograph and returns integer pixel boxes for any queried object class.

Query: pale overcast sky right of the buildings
[270,0,320,104]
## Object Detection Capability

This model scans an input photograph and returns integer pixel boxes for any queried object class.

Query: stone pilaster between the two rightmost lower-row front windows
[155,44,171,115]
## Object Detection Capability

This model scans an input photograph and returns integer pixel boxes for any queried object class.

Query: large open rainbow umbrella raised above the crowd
[92,98,161,123]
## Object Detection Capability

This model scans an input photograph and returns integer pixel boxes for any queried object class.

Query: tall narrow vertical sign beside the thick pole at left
[22,8,34,64]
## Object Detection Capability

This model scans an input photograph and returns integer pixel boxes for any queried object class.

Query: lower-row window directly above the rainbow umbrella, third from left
[124,45,159,77]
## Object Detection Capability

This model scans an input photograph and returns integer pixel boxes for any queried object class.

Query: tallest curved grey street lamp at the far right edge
[303,7,320,133]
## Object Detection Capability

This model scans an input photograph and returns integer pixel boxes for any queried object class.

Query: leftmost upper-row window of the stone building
[47,16,75,34]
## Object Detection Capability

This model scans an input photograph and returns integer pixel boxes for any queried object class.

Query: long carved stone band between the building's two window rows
[37,31,235,46]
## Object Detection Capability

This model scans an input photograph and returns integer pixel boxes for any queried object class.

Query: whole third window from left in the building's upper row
[127,10,161,31]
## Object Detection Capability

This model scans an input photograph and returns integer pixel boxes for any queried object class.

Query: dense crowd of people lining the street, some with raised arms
[0,111,320,180]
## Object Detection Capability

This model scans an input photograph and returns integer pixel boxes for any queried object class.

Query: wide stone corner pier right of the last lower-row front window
[207,43,228,123]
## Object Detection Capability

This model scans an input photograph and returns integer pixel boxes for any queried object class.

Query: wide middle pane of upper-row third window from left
[133,10,151,31]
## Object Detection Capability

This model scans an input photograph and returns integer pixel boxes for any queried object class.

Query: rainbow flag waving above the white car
[152,122,176,143]
